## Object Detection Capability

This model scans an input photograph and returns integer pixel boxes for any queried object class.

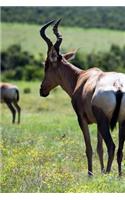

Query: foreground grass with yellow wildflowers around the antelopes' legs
[0,82,125,192]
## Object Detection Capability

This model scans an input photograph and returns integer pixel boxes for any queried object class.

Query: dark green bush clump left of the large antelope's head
[1,44,43,81]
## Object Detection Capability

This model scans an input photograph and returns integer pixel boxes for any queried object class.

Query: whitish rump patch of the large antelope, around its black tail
[92,72,125,120]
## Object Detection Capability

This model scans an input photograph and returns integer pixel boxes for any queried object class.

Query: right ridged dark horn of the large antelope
[53,19,62,53]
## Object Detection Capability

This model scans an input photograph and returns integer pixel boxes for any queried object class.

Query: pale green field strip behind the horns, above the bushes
[1,23,125,56]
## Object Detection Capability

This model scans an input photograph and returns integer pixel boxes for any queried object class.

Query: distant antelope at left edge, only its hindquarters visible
[0,83,21,123]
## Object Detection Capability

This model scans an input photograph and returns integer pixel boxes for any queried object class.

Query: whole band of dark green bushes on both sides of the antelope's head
[1,44,125,81]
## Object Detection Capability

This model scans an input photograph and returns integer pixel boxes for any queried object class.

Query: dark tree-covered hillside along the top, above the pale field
[1,7,125,30]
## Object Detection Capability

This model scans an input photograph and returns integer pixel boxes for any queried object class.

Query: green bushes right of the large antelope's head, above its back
[72,44,125,72]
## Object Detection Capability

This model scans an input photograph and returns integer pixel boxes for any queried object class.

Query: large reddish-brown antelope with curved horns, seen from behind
[40,20,125,175]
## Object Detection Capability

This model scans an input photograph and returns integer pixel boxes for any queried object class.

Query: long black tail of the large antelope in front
[110,90,123,131]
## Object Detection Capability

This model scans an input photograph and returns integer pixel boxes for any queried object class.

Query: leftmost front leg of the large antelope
[78,115,93,176]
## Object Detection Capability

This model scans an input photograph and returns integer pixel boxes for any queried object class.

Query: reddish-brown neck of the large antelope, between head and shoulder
[58,60,82,97]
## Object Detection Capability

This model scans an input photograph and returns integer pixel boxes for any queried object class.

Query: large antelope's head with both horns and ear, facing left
[40,19,75,97]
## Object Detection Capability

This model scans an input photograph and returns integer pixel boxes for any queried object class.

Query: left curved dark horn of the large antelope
[40,20,55,50]
